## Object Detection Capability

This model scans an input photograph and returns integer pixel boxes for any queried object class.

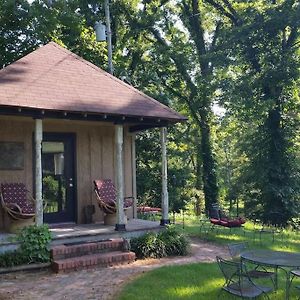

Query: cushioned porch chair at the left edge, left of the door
[0,183,35,220]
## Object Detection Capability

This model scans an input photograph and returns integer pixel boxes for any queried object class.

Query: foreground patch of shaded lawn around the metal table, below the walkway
[117,263,297,300]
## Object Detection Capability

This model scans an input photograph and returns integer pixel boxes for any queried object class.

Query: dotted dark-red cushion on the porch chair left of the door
[1,183,35,214]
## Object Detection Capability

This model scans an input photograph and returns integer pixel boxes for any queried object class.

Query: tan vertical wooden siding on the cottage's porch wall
[0,116,132,228]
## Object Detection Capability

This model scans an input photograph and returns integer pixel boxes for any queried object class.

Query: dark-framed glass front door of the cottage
[42,133,76,223]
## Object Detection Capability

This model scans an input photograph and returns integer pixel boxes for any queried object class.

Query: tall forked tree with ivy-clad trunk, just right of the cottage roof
[116,1,218,210]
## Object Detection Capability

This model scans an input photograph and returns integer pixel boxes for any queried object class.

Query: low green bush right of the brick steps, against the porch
[131,226,189,258]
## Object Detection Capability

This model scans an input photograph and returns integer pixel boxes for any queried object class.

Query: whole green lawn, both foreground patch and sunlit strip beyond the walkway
[118,219,300,300]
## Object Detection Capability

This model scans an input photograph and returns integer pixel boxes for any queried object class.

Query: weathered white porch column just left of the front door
[34,119,43,225]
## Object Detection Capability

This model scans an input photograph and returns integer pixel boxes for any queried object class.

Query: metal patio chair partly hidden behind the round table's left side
[227,242,277,290]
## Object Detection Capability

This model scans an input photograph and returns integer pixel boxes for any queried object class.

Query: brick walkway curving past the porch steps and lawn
[0,239,227,300]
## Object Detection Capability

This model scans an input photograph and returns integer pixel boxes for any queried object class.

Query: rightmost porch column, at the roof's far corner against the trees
[160,127,170,226]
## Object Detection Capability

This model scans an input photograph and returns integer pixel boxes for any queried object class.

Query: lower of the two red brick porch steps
[52,251,135,273]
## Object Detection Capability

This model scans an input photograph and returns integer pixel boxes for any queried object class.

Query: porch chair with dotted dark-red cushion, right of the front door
[94,179,133,215]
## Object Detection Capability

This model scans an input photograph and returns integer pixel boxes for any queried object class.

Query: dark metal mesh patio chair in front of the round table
[217,256,272,299]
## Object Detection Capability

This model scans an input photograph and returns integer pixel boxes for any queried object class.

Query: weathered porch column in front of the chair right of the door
[115,124,126,231]
